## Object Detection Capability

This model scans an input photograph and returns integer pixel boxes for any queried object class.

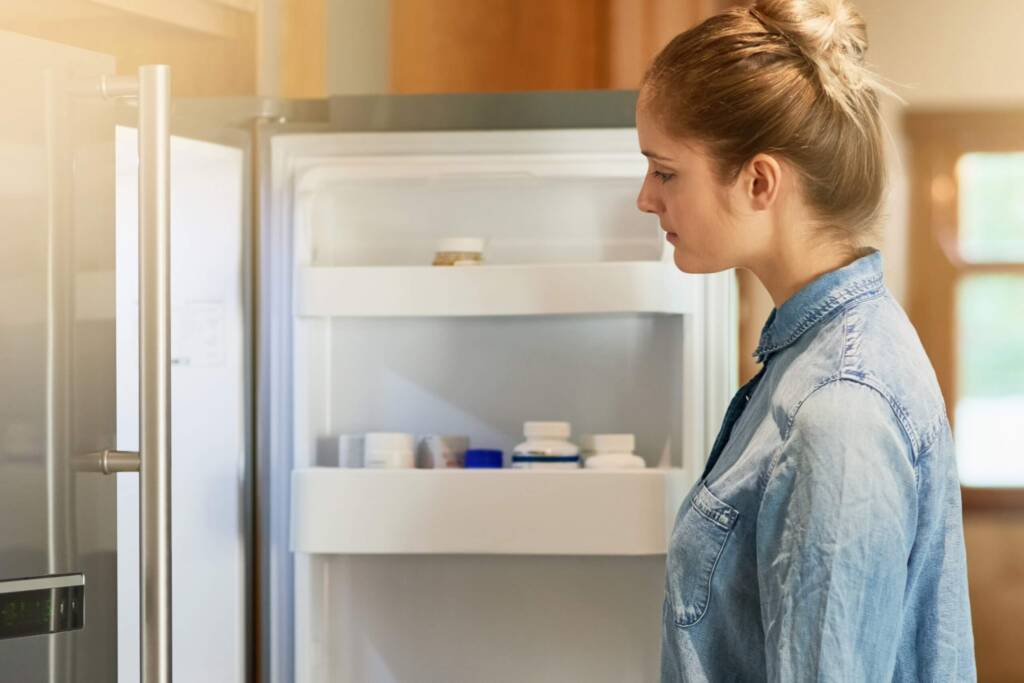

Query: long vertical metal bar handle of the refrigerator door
[138,66,171,683]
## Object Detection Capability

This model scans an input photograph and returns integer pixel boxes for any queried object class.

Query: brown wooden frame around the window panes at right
[903,109,1024,512]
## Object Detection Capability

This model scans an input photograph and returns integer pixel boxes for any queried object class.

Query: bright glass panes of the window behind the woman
[954,153,1024,486]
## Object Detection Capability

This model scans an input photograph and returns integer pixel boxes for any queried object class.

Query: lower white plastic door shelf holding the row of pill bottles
[291,468,689,555]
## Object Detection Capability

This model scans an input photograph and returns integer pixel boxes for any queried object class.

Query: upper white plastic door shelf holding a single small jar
[295,261,695,317]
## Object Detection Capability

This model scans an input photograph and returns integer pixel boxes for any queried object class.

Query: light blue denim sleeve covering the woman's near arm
[757,380,918,683]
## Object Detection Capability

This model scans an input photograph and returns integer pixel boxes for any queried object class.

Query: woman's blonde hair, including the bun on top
[641,0,888,248]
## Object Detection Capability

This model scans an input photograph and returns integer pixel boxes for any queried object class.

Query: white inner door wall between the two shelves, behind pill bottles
[307,314,683,467]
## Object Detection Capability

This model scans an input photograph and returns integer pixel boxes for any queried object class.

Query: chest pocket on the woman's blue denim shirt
[666,484,739,628]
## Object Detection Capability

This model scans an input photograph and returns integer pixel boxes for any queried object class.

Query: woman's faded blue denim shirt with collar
[662,252,976,683]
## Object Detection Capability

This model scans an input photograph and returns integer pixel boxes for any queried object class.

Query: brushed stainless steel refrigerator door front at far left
[0,32,117,683]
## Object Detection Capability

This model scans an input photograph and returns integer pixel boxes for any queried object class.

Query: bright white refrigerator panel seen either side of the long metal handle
[117,128,248,683]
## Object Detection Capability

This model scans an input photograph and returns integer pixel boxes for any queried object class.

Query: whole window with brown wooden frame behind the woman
[907,113,1024,497]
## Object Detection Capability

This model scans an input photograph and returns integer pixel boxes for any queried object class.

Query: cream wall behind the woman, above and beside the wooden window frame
[854,0,1024,300]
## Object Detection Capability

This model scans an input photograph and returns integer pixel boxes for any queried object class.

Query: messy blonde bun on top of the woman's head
[750,0,888,118]
